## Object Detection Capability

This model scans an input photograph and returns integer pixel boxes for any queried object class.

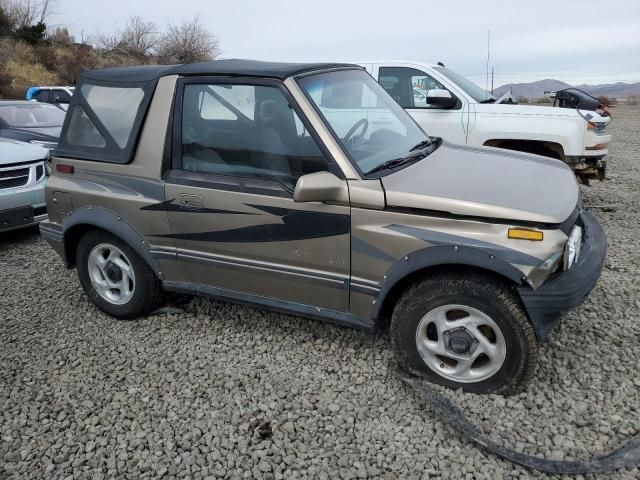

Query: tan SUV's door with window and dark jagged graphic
[165,78,350,311]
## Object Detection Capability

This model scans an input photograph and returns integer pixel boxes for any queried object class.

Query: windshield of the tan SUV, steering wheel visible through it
[298,70,429,173]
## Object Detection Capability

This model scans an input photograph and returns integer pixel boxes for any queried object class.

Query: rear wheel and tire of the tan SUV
[76,230,163,319]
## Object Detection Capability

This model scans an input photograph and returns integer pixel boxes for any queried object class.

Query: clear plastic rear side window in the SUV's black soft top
[55,81,155,163]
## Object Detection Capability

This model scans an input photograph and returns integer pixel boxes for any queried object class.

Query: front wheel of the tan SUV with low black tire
[391,274,538,394]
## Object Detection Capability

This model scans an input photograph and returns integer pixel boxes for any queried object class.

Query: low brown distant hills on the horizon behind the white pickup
[493,79,640,98]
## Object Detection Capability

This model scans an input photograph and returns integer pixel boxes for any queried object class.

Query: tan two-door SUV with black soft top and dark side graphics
[41,60,606,393]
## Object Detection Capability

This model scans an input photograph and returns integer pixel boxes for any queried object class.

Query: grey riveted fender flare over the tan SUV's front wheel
[372,245,525,321]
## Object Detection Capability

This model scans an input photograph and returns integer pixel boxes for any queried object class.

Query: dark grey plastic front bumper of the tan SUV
[518,212,607,340]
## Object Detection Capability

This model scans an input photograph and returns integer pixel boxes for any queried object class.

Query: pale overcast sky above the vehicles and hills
[56,0,640,87]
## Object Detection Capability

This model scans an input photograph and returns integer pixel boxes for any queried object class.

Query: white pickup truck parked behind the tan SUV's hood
[357,61,611,183]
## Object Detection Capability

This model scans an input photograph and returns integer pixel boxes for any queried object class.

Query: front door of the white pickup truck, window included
[376,66,467,143]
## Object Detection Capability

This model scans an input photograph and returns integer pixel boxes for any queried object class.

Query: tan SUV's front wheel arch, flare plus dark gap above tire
[373,245,525,326]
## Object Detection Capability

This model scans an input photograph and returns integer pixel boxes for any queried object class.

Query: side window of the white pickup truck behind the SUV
[378,67,446,108]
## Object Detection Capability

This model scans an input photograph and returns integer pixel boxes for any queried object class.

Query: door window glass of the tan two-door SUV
[180,84,330,190]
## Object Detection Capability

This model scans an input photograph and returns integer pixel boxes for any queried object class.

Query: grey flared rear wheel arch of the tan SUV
[63,207,163,280]
